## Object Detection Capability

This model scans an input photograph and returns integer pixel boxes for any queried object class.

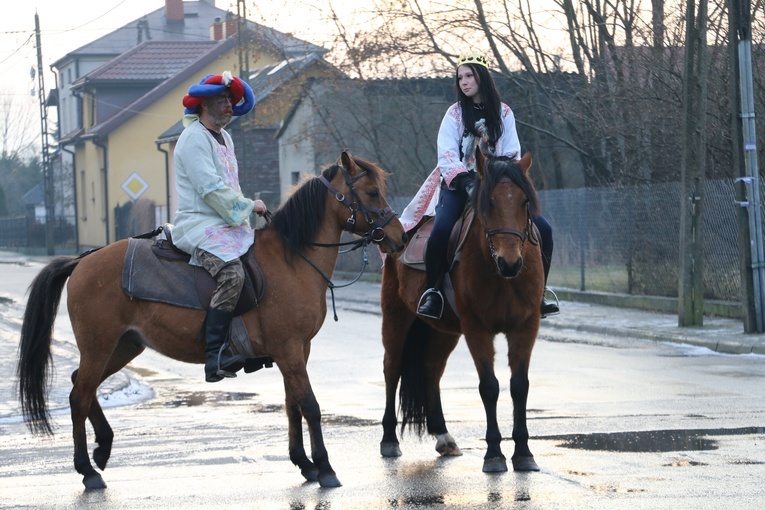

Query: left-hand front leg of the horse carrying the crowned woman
[465,334,507,473]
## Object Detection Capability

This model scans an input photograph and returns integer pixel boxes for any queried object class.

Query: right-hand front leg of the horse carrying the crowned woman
[509,330,539,471]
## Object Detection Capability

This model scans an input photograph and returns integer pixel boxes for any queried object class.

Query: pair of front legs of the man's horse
[279,361,341,487]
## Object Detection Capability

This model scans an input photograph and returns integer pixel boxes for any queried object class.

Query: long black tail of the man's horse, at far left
[16,257,80,434]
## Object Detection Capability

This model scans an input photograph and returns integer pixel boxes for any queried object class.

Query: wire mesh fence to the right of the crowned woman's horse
[539,180,741,302]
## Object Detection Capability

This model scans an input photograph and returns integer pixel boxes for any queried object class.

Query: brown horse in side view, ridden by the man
[18,151,406,489]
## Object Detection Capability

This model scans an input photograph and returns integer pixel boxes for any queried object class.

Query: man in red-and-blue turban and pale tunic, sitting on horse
[172,71,266,382]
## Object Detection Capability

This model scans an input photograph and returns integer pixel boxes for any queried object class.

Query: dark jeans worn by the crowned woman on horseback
[425,182,553,289]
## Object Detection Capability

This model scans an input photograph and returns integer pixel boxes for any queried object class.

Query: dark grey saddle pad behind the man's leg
[122,238,206,310]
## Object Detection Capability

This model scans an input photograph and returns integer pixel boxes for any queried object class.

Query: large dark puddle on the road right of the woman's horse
[536,427,765,453]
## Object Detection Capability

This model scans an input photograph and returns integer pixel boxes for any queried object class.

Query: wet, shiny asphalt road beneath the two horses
[0,256,765,510]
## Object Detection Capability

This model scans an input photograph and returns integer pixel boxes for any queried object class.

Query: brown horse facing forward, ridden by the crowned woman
[380,152,544,472]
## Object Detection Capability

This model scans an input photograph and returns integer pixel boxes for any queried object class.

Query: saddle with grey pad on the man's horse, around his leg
[122,224,266,316]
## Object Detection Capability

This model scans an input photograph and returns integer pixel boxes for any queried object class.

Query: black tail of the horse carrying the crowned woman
[399,318,431,437]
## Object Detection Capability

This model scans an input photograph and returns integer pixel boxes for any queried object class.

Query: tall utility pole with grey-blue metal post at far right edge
[728,0,765,333]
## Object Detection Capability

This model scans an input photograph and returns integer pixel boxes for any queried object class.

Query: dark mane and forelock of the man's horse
[267,156,387,254]
